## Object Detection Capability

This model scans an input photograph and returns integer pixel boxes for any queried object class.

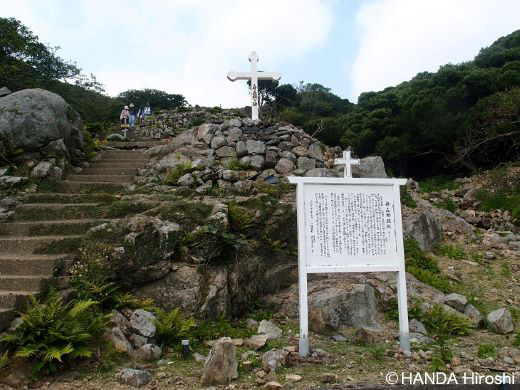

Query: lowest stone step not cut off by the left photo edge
[14,203,107,222]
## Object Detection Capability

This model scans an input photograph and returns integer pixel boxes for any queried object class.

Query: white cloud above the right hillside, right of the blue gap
[351,0,520,98]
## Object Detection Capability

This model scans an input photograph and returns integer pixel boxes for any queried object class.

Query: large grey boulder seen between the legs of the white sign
[309,284,381,331]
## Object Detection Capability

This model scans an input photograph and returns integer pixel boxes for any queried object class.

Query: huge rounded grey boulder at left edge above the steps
[0,89,83,152]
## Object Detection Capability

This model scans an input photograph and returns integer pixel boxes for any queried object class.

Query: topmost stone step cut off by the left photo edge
[0,218,109,237]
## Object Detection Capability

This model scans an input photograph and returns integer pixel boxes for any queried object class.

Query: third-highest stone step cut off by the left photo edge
[0,254,70,276]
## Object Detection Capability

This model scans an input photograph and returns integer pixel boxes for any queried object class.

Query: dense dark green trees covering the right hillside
[268,30,520,177]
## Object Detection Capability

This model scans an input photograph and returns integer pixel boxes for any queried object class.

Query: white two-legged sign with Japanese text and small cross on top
[289,152,410,356]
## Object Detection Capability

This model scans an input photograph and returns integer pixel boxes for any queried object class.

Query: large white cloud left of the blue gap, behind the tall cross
[0,0,332,107]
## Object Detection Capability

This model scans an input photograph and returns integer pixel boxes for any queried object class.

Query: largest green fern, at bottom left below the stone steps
[0,292,107,373]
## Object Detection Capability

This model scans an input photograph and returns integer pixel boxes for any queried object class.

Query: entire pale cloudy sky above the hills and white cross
[0,0,520,107]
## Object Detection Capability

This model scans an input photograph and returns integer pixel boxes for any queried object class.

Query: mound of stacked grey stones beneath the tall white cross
[140,118,387,193]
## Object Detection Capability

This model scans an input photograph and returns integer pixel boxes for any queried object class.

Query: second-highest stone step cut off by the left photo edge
[0,235,82,254]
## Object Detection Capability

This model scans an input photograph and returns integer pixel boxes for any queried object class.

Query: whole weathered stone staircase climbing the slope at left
[0,150,148,331]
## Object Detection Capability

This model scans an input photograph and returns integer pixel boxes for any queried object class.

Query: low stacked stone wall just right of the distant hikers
[131,107,240,139]
